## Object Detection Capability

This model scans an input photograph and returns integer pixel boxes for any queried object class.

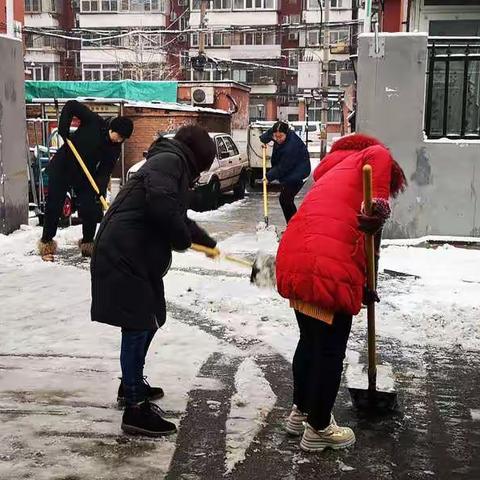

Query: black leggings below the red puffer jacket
[293,311,352,430]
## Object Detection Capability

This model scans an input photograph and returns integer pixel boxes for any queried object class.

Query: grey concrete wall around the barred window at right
[357,34,480,238]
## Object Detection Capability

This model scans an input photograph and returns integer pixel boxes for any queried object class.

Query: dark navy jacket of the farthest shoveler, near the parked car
[260,129,311,185]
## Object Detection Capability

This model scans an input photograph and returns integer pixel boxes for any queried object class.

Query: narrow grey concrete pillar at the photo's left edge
[0,36,28,233]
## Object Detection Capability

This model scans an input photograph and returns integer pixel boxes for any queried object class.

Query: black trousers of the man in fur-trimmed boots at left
[42,168,102,243]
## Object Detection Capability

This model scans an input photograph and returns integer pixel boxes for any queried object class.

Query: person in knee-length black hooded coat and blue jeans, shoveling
[91,125,218,436]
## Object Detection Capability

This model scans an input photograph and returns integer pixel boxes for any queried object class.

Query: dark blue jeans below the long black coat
[120,328,156,405]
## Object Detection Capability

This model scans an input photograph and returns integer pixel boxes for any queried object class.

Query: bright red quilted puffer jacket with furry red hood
[276,134,405,315]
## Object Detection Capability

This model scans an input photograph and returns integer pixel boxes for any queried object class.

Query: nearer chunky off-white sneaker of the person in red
[300,415,355,452]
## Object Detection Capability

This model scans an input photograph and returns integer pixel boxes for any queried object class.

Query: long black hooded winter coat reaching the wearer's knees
[91,138,216,330]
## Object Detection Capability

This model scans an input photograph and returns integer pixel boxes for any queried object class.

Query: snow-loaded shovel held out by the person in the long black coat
[190,243,277,288]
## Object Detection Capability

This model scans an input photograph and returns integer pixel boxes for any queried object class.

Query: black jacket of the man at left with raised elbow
[48,100,122,195]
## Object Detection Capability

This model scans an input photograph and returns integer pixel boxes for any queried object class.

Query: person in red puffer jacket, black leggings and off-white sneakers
[276,134,406,451]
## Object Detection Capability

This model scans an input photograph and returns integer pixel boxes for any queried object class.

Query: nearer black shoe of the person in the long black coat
[122,400,177,437]
